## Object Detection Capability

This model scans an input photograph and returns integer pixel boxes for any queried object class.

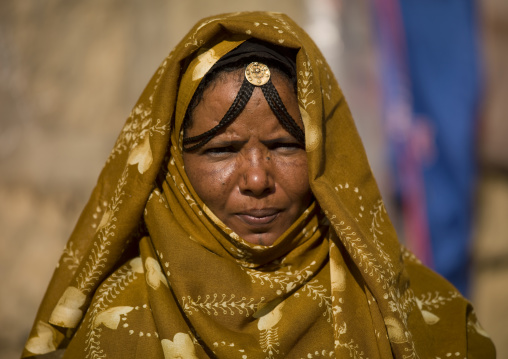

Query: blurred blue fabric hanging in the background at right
[400,0,481,295]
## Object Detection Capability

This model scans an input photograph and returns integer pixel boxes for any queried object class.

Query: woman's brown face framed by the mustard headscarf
[183,70,312,245]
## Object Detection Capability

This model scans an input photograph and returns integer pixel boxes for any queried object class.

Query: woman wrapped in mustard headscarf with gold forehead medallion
[24,12,495,358]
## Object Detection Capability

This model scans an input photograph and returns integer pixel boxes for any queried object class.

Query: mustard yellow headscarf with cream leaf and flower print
[23,12,495,359]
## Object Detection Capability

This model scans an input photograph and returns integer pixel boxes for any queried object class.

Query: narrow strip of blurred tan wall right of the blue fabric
[471,0,508,358]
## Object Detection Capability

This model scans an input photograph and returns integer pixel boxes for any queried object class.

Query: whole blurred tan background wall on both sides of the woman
[0,0,508,358]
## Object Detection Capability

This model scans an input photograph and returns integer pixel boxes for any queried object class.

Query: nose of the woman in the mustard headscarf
[239,151,275,197]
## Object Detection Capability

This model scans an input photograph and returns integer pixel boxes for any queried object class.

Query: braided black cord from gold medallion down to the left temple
[183,79,254,151]
